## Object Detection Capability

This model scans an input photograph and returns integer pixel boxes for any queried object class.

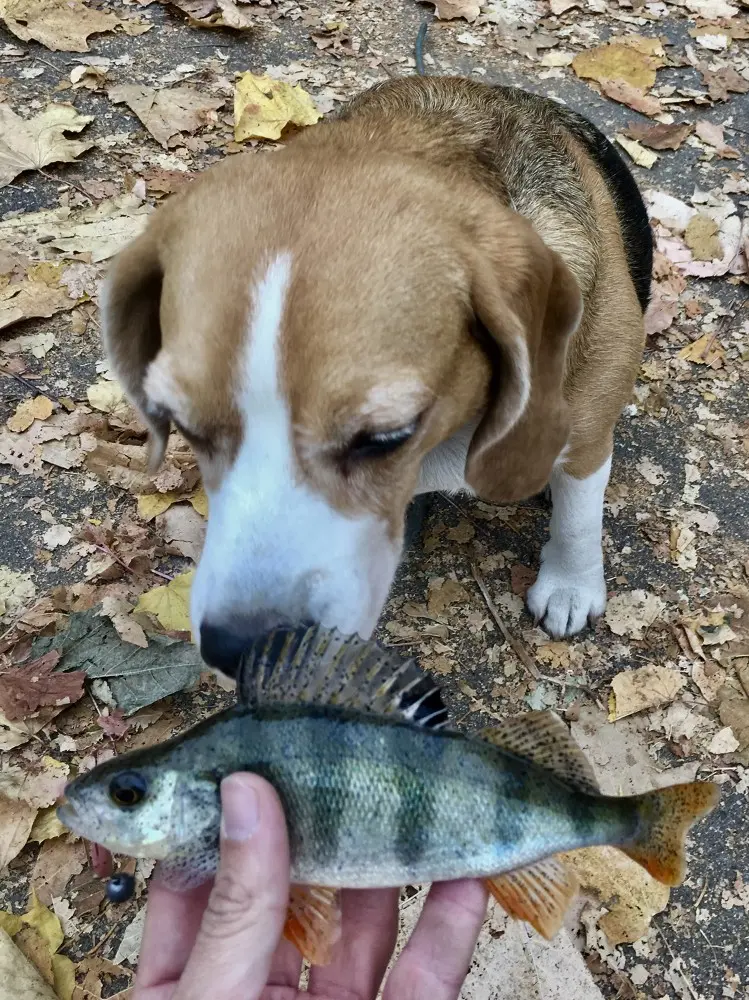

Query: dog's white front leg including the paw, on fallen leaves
[528,456,611,637]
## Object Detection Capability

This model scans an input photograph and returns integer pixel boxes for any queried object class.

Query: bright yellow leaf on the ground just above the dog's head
[234,73,322,142]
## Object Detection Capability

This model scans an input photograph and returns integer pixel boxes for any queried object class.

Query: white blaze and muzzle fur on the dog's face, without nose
[192,253,400,637]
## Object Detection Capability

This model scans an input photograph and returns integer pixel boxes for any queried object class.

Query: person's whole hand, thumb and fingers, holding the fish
[133,774,486,1000]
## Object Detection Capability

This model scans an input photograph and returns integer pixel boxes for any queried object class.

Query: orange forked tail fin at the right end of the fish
[621,781,720,885]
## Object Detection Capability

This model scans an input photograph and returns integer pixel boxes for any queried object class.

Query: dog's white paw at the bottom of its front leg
[527,547,606,639]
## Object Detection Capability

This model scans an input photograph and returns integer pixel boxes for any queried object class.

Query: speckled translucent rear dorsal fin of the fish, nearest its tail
[478,712,600,795]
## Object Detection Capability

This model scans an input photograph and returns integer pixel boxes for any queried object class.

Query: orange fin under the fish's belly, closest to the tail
[486,858,578,941]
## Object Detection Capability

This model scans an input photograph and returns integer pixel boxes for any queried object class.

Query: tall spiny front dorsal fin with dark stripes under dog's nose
[237,626,448,729]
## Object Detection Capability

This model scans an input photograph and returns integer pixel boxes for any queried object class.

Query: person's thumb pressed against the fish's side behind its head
[173,773,289,1000]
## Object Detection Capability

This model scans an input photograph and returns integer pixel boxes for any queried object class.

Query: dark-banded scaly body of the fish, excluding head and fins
[152,709,635,887]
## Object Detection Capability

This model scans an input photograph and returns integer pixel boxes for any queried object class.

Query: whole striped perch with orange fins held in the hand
[58,628,719,962]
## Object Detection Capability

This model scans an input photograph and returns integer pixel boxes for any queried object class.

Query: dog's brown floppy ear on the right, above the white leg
[465,212,583,503]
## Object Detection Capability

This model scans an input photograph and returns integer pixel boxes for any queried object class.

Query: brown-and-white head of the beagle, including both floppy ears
[103,144,582,673]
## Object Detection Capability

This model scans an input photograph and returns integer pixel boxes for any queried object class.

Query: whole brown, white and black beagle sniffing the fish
[103,77,652,674]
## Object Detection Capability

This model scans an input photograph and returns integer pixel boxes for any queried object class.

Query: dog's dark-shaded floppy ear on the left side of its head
[101,222,169,471]
